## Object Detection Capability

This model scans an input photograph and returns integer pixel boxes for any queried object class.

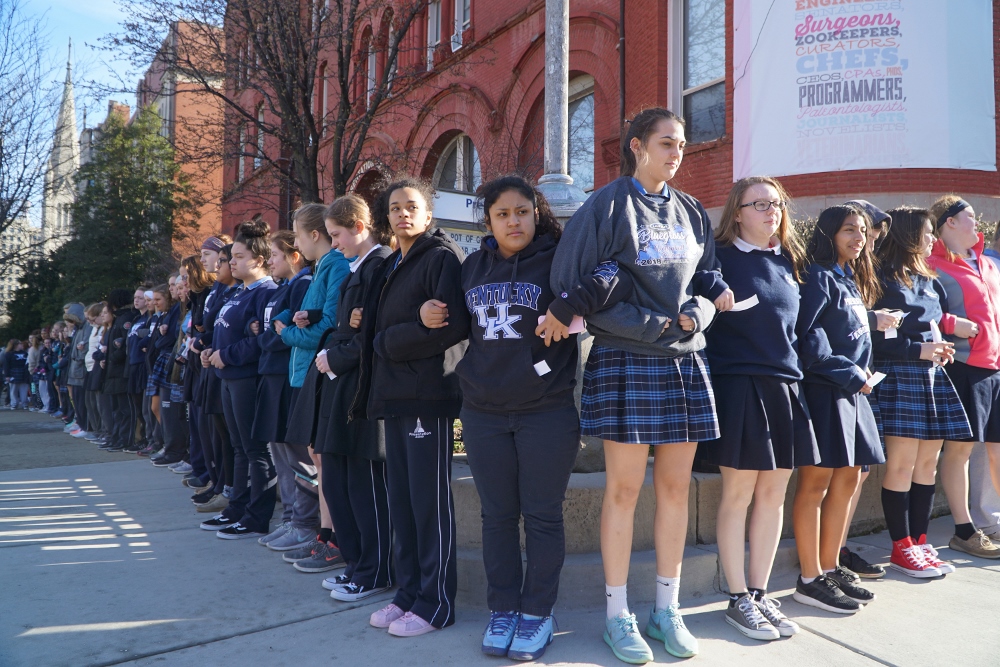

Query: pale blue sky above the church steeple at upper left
[22,0,138,131]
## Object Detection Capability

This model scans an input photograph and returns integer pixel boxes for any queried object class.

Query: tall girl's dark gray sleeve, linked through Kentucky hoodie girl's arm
[550,197,670,343]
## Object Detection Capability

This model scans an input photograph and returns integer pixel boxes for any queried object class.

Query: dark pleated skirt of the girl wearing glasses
[697,375,820,470]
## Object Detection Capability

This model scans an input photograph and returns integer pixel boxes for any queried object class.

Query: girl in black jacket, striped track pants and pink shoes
[351,178,469,637]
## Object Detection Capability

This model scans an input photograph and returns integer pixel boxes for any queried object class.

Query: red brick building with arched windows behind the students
[223,0,1000,237]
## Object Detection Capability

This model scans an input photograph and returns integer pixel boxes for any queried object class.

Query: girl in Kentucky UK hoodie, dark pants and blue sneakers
[422,176,631,660]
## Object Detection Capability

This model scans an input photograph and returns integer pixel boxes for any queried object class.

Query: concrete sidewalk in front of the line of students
[0,412,1000,667]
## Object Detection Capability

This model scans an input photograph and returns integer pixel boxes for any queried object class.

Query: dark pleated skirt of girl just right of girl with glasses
[802,382,885,468]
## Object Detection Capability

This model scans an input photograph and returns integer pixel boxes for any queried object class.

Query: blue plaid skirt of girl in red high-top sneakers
[872,360,972,440]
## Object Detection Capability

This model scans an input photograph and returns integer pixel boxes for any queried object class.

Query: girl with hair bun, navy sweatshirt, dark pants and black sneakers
[201,219,277,540]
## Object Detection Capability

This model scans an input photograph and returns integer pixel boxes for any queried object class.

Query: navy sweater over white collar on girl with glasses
[705,242,802,381]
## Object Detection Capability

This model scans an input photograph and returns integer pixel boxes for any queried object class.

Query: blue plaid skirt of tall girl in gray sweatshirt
[580,345,719,445]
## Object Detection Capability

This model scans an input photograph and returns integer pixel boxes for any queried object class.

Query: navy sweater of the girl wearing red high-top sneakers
[872,275,948,361]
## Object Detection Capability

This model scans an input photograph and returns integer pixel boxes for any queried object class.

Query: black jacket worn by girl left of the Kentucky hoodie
[351,229,469,419]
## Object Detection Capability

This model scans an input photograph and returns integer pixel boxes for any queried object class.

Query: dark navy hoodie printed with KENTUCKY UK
[458,234,632,413]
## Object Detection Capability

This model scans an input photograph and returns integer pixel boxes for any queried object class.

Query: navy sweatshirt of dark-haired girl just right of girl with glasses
[795,264,872,394]
